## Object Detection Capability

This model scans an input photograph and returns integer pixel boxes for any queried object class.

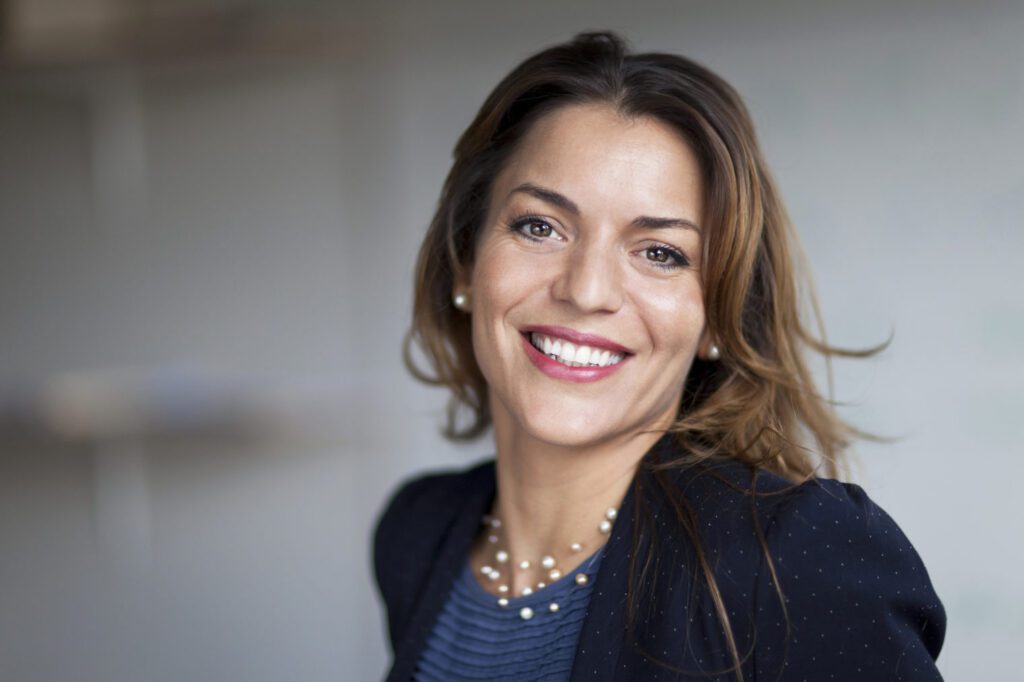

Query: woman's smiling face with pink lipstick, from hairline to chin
[461,100,708,446]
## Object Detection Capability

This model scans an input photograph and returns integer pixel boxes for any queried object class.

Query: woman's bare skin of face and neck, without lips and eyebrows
[456,104,712,595]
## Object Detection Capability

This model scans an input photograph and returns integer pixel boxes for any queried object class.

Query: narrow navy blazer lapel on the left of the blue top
[387,462,495,682]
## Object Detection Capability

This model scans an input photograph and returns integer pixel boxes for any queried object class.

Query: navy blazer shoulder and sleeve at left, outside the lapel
[373,460,495,642]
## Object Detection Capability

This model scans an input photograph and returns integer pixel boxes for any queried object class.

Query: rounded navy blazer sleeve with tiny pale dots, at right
[758,478,946,680]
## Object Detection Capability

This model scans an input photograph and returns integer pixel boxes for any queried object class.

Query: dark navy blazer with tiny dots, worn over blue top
[374,436,946,682]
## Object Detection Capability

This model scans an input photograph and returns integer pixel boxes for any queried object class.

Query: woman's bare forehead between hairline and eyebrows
[493,104,701,221]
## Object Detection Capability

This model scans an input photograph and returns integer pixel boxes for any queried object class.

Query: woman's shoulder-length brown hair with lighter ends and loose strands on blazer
[403,32,891,680]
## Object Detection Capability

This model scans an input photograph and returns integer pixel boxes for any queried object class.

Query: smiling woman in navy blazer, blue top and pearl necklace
[375,33,945,681]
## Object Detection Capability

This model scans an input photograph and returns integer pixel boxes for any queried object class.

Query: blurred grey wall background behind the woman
[0,0,1024,682]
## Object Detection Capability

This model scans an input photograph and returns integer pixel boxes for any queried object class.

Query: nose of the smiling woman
[552,229,624,312]
